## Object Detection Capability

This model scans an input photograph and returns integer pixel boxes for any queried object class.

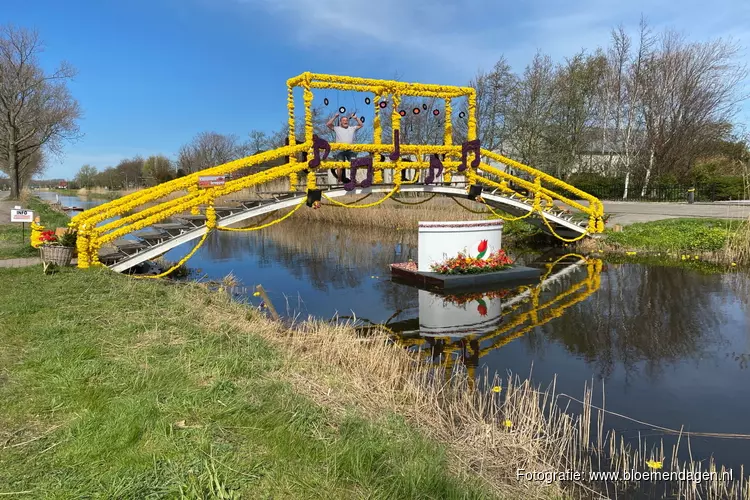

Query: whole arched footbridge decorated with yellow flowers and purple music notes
[71,73,604,276]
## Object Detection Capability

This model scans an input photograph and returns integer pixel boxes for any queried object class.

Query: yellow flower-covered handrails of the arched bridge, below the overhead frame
[71,139,603,267]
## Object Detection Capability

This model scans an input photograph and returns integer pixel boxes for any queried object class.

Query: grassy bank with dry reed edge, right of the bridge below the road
[579,218,750,265]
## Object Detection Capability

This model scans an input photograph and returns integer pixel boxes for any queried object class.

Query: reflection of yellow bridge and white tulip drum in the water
[378,255,602,379]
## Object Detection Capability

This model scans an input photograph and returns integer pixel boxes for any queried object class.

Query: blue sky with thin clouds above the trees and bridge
[0,0,750,178]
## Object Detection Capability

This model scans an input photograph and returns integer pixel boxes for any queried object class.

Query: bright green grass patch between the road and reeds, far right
[606,219,741,252]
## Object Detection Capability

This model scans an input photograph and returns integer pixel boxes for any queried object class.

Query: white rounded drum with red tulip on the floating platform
[417,220,503,272]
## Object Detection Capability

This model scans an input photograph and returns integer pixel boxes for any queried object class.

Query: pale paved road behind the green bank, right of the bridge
[604,201,750,226]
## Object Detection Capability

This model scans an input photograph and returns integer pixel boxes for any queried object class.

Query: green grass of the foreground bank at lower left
[0,267,488,499]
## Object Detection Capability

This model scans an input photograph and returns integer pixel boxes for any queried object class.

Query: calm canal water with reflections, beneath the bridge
[42,191,750,477]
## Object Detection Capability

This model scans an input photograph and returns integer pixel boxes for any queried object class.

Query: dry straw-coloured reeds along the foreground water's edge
[191,286,750,500]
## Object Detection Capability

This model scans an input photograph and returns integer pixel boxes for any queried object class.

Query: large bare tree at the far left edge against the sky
[0,26,81,199]
